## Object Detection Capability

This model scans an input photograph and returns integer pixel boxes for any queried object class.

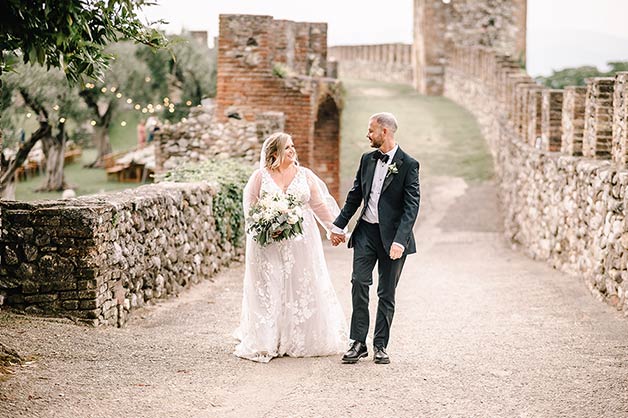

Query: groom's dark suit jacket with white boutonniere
[334,148,421,254]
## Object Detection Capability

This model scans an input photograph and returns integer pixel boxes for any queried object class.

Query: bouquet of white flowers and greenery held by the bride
[246,193,303,247]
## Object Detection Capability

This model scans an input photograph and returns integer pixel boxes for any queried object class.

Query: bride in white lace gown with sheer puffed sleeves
[234,133,348,363]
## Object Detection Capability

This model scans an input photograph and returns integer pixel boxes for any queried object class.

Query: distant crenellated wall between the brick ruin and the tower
[329,43,413,84]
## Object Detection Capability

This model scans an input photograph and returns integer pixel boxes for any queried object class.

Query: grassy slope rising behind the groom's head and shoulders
[340,80,493,190]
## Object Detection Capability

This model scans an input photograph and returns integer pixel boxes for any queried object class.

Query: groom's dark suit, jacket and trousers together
[334,148,421,348]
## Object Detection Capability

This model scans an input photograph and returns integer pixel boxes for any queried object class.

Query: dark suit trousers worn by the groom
[350,220,406,348]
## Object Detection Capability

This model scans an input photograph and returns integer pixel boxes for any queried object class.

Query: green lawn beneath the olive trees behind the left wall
[15,112,139,201]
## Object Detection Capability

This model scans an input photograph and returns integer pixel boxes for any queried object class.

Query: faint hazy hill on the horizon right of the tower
[527,30,628,76]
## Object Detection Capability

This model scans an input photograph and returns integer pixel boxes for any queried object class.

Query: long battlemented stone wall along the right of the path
[444,48,628,315]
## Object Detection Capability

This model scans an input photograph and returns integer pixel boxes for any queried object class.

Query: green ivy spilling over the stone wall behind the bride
[156,160,254,247]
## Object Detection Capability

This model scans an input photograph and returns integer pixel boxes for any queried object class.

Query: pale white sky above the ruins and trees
[145,0,628,76]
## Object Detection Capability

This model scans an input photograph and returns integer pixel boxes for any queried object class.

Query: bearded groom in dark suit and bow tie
[331,113,420,364]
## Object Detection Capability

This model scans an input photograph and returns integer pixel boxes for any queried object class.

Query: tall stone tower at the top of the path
[414,0,527,95]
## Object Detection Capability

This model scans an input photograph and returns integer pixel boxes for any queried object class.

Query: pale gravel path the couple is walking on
[0,178,628,418]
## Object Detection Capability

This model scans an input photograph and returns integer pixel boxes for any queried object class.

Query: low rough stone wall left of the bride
[0,183,242,326]
